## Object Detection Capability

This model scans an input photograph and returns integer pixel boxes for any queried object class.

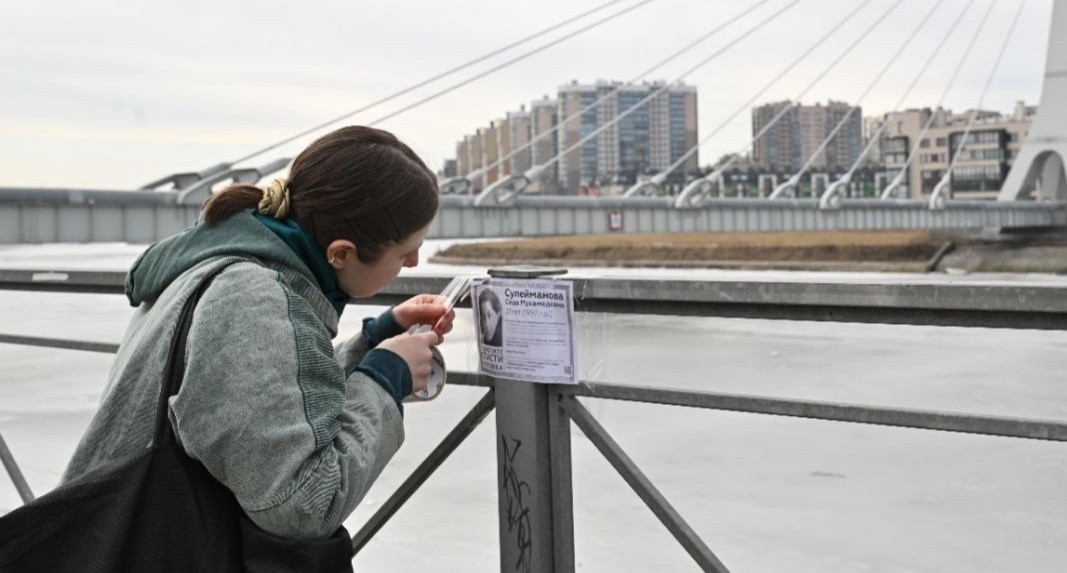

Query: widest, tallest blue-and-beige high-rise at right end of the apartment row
[557,81,699,193]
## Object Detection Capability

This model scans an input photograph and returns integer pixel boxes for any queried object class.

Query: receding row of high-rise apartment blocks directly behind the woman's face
[443,80,699,194]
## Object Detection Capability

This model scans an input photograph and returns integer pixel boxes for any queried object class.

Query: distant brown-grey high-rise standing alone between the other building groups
[752,100,863,173]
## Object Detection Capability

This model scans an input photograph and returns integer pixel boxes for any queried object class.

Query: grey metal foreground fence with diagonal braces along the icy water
[0,270,1067,572]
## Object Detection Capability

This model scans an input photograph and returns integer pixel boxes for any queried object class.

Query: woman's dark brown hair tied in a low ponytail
[203,126,439,262]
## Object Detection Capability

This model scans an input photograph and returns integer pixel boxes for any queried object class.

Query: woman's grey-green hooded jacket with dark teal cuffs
[63,212,410,539]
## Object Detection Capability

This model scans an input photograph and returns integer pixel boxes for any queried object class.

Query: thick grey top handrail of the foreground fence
[0,269,1067,330]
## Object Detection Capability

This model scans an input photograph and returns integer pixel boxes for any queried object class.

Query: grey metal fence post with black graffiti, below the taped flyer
[490,267,574,573]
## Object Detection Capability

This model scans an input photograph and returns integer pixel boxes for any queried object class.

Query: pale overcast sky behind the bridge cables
[0,0,1052,189]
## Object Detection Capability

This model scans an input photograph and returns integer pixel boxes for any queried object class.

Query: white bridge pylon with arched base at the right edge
[997,0,1067,201]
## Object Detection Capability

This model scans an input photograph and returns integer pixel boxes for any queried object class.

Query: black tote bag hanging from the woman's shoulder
[0,269,352,573]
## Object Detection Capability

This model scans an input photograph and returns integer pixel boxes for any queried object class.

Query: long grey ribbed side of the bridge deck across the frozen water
[0,188,1067,244]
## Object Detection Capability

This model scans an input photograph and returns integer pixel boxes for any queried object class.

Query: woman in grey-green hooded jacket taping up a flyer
[64,127,453,539]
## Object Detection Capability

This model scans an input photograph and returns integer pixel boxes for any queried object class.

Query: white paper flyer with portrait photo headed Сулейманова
[471,278,578,384]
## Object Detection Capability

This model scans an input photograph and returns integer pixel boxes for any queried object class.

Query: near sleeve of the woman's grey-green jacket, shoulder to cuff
[171,269,403,539]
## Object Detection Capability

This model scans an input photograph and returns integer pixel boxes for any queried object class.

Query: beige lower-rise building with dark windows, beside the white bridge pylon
[882,101,1036,198]
